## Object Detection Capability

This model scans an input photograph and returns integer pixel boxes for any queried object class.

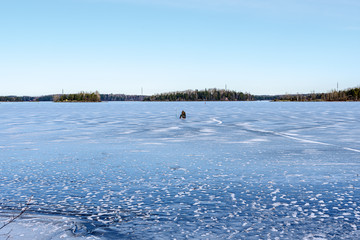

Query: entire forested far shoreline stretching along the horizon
[0,87,360,102]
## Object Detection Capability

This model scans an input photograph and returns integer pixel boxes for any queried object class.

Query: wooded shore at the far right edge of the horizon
[272,87,360,102]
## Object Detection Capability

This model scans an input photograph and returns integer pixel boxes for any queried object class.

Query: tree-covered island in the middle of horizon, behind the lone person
[144,88,254,101]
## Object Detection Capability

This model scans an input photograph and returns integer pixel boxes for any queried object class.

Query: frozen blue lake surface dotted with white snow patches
[0,102,360,239]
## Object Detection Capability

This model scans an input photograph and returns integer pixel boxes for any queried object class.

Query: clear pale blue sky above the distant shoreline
[0,0,360,96]
